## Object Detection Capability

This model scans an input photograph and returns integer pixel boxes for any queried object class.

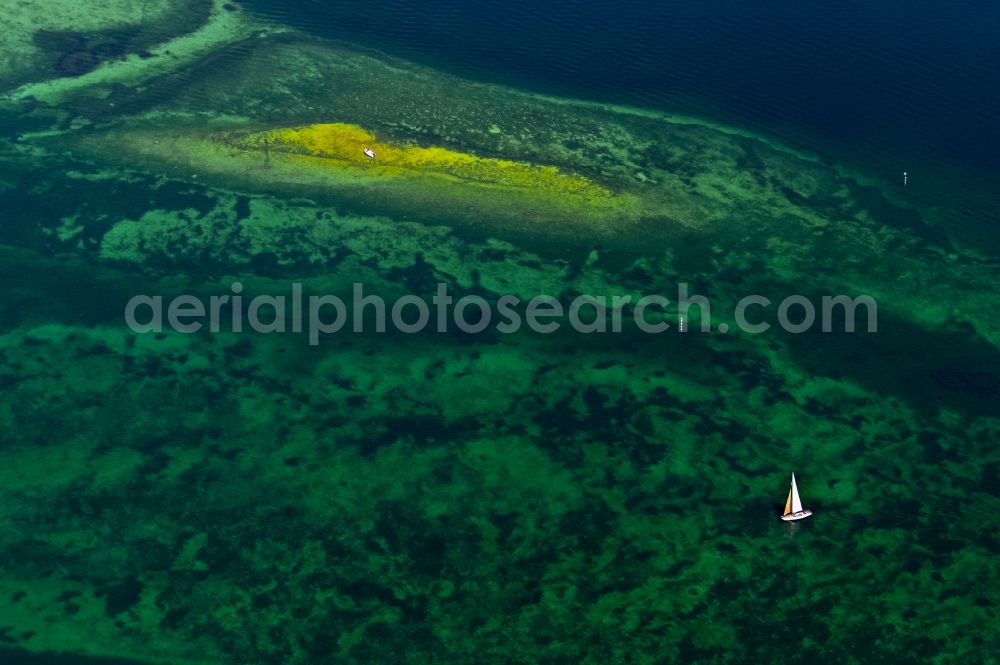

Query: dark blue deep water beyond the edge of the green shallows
[247,0,1000,197]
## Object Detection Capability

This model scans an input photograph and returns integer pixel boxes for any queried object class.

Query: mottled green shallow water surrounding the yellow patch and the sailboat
[0,1,1000,663]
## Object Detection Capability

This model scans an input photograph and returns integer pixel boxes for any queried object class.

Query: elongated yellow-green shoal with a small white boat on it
[88,123,644,232]
